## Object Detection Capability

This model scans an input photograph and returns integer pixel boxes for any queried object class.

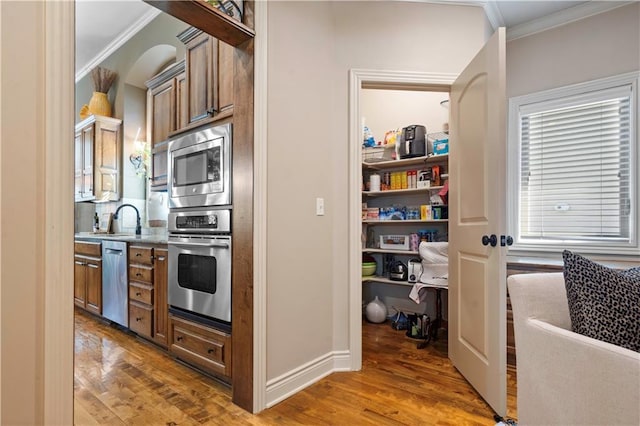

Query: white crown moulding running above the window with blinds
[504,1,634,41]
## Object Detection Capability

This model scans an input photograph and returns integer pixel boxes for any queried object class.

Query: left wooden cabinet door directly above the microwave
[186,33,218,123]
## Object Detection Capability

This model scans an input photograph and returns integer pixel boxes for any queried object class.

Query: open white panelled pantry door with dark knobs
[449,28,507,416]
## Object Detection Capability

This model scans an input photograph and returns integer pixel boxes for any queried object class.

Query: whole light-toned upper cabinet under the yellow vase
[75,115,122,202]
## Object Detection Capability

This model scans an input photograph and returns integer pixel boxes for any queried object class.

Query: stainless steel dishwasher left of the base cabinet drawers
[102,240,129,327]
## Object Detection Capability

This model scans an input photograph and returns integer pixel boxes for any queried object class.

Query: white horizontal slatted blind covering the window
[517,84,635,245]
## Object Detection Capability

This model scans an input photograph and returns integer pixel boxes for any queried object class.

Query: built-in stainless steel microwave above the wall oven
[167,123,232,208]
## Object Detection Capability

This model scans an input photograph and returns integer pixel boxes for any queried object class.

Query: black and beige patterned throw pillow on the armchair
[562,250,640,352]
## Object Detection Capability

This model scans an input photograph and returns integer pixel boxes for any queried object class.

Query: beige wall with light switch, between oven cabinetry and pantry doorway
[266,1,487,383]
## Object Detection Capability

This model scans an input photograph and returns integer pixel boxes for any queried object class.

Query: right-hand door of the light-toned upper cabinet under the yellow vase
[94,118,122,201]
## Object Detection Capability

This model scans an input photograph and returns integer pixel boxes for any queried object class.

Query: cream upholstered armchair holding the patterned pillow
[508,273,640,425]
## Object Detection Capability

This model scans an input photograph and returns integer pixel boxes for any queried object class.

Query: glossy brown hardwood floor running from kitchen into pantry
[74,310,516,425]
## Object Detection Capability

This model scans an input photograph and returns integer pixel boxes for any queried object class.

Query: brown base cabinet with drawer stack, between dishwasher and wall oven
[129,244,168,348]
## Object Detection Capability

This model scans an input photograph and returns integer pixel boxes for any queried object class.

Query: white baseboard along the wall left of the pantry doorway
[265,351,351,408]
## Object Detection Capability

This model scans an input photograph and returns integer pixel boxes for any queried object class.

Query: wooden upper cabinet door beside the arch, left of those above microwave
[149,79,176,149]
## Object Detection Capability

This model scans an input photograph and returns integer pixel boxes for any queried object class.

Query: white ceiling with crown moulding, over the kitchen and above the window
[76,0,631,81]
